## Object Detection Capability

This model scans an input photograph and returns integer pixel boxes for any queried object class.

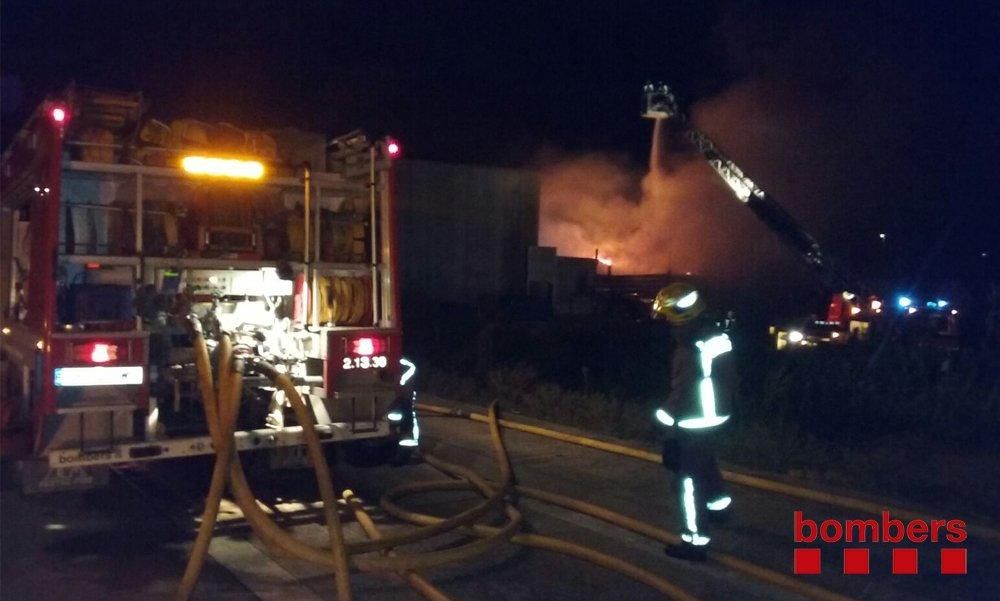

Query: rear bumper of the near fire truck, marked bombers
[48,421,397,467]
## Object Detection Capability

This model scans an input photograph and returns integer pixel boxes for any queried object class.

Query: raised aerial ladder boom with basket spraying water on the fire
[642,83,853,290]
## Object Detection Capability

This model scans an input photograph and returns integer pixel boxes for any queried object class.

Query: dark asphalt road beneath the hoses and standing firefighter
[0,400,1000,601]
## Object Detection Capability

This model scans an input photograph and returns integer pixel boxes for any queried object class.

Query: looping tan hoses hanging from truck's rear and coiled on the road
[176,316,694,601]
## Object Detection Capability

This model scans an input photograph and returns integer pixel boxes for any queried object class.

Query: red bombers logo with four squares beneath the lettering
[793,511,968,574]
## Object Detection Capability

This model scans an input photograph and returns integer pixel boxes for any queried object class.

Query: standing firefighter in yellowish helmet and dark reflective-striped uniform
[653,282,734,561]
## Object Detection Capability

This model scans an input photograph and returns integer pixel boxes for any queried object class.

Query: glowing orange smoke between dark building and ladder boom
[539,109,808,288]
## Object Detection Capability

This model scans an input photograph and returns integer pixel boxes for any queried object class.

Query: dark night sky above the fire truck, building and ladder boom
[0,0,1000,288]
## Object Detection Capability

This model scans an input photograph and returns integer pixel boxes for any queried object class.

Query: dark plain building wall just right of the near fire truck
[396,160,538,303]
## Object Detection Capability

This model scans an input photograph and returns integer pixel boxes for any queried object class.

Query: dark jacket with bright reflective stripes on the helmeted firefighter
[656,332,735,431]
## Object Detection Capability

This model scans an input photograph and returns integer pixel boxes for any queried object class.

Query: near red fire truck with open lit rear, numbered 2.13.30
[0,86,418,490]
